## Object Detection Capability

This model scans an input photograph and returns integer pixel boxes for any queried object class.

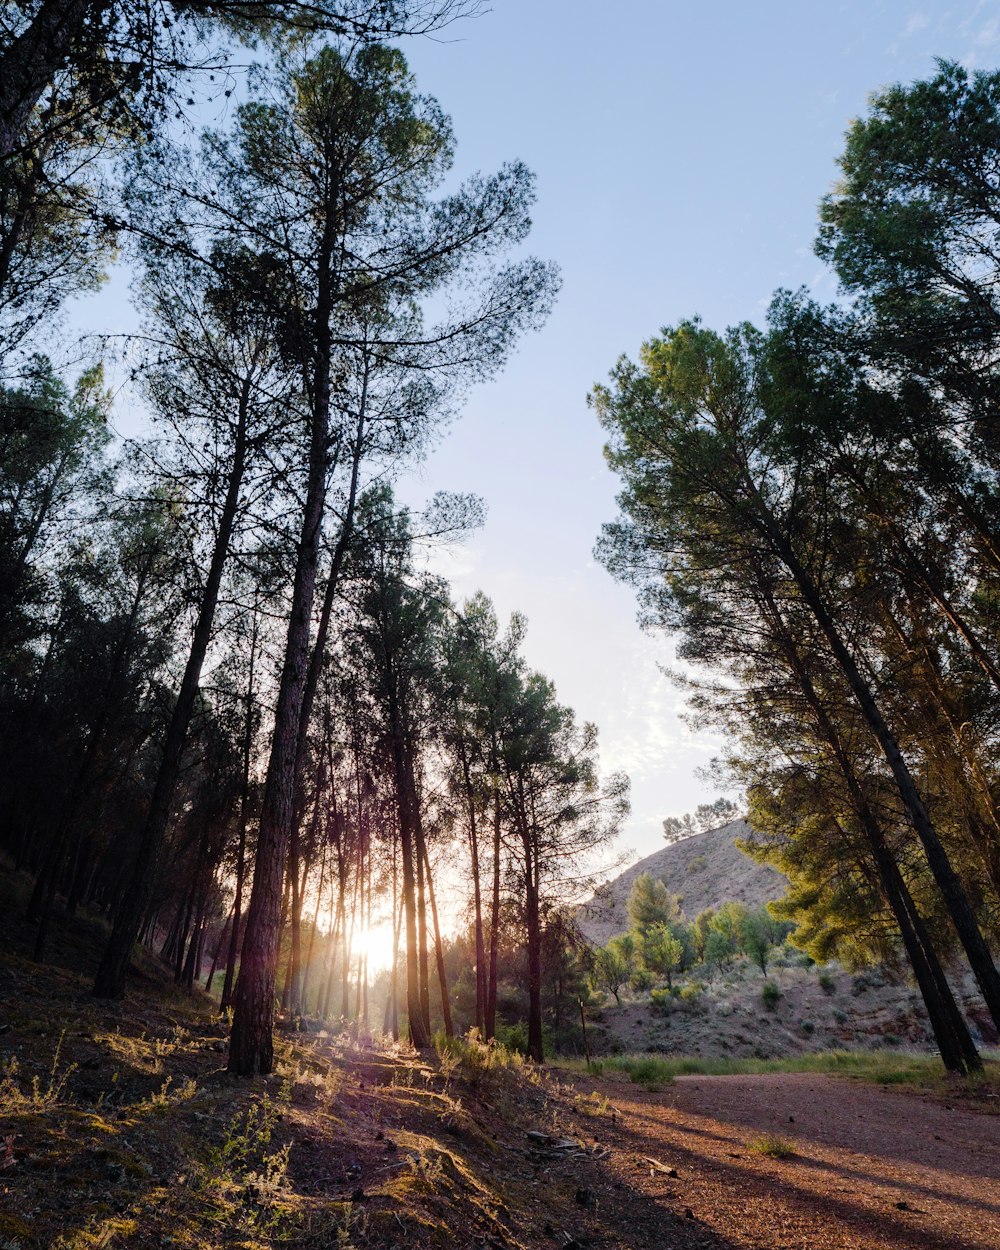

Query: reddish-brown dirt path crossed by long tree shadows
[576,1074,1000,1250]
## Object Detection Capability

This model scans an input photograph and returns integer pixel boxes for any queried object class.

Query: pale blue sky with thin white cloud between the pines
[66,0,1000,875]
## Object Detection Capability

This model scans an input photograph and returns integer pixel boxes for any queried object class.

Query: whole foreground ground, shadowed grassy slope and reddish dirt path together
[0,874,1000,1250]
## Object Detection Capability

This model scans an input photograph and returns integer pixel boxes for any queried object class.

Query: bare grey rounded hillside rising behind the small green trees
[576,820,788,945]
